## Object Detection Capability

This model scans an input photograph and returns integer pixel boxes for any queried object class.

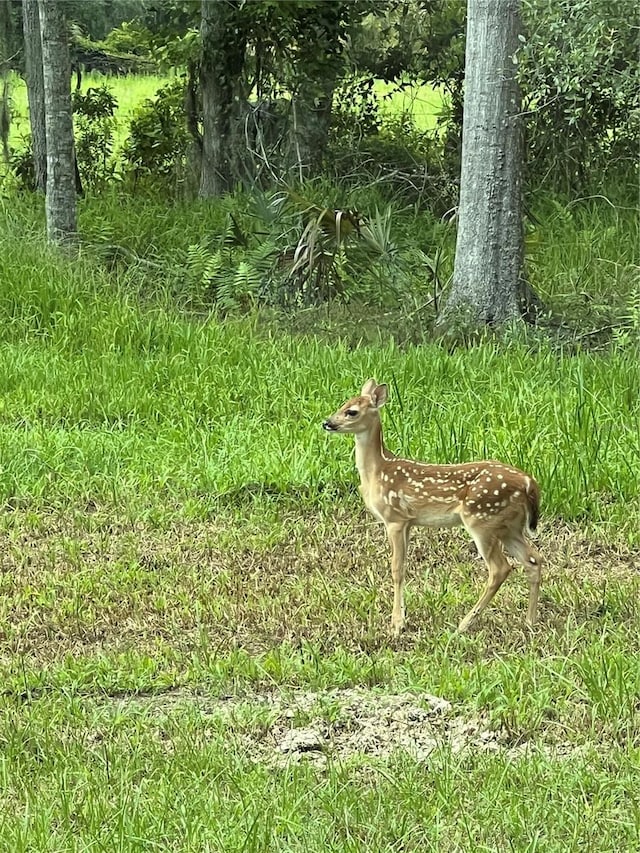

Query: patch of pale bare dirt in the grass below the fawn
[133,688,596,767]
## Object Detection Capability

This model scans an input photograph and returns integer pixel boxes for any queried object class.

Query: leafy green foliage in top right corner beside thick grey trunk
[520,0,640,188]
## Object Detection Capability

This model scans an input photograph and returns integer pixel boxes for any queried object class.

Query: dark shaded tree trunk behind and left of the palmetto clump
[199,0,246,198]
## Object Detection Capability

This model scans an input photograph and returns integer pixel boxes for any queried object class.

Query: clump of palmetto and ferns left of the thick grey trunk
[177,185,442,311]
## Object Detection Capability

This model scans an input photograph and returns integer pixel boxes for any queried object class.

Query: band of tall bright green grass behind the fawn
[0,204,640,537]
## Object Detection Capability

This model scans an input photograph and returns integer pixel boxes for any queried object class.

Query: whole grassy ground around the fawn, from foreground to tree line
[0,79,640,853]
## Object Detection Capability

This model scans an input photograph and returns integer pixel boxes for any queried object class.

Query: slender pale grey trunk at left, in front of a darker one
[38,0,78,244]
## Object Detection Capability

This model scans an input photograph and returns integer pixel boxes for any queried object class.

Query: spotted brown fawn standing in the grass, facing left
[323,379,542,636]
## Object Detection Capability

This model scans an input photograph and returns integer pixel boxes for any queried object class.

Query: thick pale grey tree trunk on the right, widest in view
[438,0,527,329]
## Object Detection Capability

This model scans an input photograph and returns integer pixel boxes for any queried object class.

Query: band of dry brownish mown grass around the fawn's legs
[0,506,640,663]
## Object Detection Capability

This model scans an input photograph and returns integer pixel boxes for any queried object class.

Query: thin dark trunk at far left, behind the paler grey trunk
[22,0,47,193]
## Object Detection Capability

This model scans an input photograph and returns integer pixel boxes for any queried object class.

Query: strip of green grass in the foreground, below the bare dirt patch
[1,688,638,853]
